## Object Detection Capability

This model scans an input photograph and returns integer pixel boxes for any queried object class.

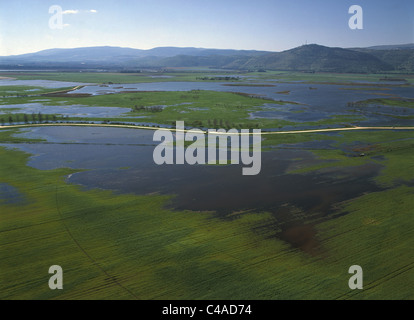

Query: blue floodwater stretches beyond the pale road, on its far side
[0,79,414,126]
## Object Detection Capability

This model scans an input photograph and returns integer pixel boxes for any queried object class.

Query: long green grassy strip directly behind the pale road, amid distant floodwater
[0,90,364,129]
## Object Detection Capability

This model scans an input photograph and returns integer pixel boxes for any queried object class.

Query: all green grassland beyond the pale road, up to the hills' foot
[0,71,412,129]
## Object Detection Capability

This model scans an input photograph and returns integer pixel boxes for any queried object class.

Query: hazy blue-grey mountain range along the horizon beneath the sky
[0,44,414,73]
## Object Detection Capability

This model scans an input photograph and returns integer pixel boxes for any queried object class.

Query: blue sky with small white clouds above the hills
[0,0,414,55]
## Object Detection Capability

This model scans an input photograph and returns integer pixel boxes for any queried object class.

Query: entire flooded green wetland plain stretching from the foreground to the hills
[0,71,414,299]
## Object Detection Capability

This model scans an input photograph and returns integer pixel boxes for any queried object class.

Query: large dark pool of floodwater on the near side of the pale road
[2,127,381,254]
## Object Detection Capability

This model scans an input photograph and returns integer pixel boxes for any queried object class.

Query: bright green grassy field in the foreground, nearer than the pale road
[0,131,414,299]
